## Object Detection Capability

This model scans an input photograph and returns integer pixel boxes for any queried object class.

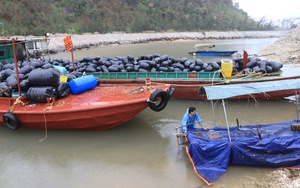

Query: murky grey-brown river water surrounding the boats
[0,39,296,188]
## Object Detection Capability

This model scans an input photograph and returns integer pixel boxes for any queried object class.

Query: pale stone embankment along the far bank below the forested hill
[49,31,286,52]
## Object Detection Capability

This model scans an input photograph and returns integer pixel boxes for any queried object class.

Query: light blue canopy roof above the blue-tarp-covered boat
[199,79,300,100]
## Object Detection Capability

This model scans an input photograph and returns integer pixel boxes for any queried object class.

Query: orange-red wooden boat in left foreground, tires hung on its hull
[0,39,174,130]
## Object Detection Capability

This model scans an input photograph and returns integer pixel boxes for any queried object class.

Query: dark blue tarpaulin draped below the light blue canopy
[186,120,300,184]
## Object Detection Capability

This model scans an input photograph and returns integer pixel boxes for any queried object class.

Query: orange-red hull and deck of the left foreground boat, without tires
[0,85,170,130]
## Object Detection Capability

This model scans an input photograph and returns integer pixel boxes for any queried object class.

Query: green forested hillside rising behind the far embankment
[0,0,274,35]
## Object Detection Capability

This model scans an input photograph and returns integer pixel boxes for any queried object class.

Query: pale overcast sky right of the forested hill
[233,0,300,21]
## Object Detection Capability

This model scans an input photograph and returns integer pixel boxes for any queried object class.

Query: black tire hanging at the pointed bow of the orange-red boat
[148,89,170,112]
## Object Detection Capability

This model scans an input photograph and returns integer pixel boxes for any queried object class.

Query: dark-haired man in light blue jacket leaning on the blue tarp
[180,107,208,133]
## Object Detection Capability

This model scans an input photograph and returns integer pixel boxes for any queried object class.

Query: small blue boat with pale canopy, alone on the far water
[189,44,237,56]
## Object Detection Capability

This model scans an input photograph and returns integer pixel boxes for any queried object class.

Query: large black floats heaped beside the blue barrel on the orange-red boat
[0,66,70,103]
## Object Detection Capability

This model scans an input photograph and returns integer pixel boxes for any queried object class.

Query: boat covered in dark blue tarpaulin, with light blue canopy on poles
[186,79,300,185]
